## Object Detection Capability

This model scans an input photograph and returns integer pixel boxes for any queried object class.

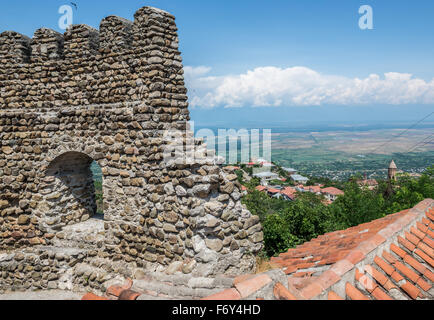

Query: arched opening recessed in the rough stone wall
[36,151,102,231]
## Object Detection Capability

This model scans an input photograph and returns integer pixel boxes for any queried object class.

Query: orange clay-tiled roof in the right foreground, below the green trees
[204,199,434,300]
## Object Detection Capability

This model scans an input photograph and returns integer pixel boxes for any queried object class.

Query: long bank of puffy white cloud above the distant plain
[185,66,434,108]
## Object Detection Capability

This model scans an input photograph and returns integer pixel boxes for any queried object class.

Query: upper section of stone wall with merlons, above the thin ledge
[0,7,187,109]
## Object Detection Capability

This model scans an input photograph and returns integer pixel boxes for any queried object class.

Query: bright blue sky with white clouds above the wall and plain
[0,0,434,126]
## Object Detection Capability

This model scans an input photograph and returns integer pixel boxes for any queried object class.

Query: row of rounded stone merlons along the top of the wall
[0,7,177,68]
